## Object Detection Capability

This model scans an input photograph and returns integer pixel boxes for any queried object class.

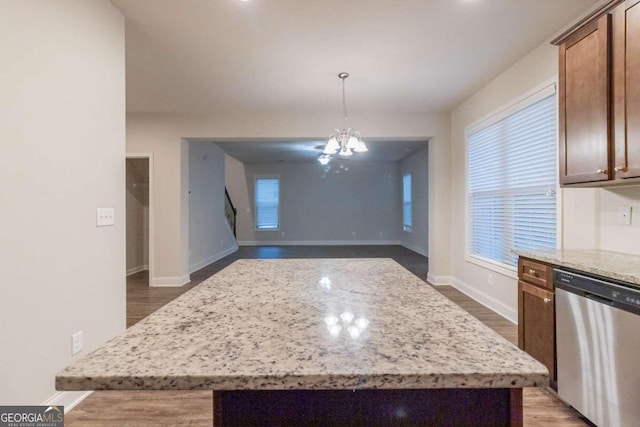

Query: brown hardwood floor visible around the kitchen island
[65,246,589,427]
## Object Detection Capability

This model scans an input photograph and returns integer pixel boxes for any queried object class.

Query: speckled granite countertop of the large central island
[56,259,548,390]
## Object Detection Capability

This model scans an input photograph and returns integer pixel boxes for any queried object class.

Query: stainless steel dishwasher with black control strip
[554,269,640,427]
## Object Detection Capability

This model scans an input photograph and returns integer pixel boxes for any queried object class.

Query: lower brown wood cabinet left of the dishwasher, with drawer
[518,257,556,388]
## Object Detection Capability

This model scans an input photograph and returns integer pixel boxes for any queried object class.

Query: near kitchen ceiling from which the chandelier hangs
[111,0,596,113]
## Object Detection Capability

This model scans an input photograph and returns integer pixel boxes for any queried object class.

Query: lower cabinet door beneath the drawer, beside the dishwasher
[518,280,556,386]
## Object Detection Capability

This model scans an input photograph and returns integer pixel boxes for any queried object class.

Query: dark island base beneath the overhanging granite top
[213,389,522,427]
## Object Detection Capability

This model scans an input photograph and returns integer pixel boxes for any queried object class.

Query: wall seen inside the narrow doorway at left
[126,159,149,274]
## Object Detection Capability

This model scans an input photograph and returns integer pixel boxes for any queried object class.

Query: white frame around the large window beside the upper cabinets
[464,76,562,279]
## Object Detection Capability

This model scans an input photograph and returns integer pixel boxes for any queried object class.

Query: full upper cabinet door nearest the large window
[559,14,613,184]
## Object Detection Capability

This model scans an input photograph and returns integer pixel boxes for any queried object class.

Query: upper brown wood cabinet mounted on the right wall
[554,0,640,185]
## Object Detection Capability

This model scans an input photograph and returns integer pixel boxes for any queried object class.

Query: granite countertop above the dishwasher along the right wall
[514,249,640,286]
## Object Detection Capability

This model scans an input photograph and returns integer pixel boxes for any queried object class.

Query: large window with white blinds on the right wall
[467,86,558,270]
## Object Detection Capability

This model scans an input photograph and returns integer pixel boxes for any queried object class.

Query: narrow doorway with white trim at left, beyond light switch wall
[126,154,153,286]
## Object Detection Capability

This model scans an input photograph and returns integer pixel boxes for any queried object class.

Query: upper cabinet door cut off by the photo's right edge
[613,0,640,178]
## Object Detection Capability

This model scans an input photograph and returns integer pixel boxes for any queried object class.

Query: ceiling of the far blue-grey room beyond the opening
[208,140,427,163]
